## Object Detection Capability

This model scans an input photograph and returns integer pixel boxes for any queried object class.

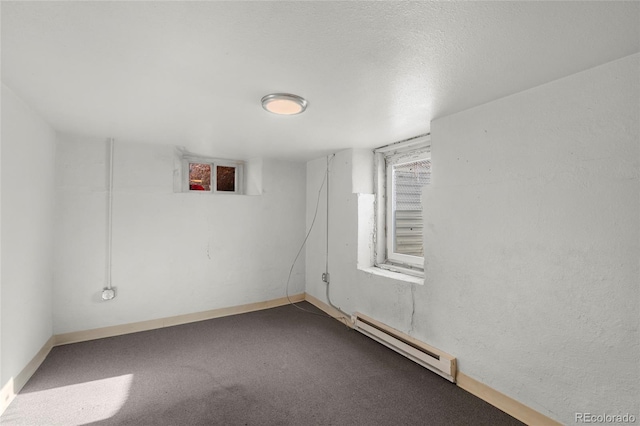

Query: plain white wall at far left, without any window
[0,84,56,386]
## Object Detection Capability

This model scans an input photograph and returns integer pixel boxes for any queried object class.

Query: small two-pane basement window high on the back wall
[183,157,244,194]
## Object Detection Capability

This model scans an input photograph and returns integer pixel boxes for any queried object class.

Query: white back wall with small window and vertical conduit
[53,135,305,334]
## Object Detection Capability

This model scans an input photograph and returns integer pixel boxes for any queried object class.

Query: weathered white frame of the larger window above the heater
[374,135,431,277]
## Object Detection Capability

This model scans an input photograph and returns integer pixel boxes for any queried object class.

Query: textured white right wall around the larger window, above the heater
[306,55,640,423]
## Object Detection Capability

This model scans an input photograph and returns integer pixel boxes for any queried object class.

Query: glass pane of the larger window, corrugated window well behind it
[392,160,431,257]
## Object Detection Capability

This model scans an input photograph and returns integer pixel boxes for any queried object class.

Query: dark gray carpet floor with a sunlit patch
[0,302,522,426]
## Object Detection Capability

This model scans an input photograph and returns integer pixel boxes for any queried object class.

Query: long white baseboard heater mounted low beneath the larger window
[352,313,456,383]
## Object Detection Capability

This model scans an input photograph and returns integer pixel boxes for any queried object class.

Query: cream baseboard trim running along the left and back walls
[0,293,305,415]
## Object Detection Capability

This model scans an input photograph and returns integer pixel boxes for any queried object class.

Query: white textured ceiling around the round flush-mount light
[1,1,640,160]
